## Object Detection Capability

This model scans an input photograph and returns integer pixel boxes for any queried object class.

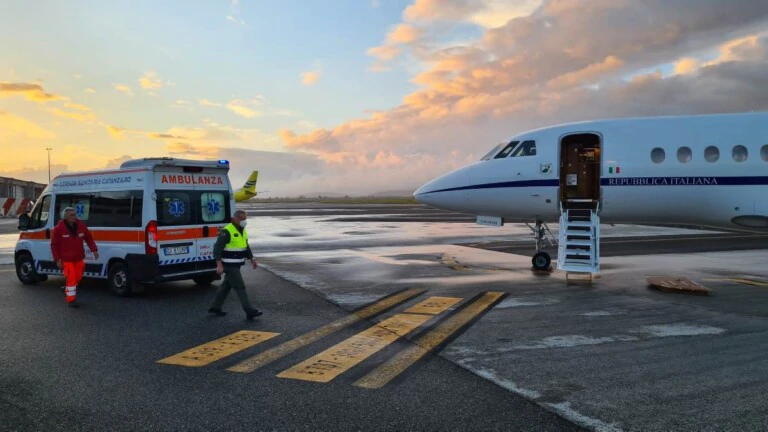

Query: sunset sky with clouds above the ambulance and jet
[0,0,768,196]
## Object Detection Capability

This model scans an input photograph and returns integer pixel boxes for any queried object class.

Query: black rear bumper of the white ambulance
[127,254,221,283]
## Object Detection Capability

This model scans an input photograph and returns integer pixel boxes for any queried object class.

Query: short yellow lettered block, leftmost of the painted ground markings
[157,330,280,367]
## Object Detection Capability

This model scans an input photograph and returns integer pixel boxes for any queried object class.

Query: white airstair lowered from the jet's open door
[557,199,600,278]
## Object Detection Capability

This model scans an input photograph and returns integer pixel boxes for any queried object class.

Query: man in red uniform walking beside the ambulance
[51,207,99,307]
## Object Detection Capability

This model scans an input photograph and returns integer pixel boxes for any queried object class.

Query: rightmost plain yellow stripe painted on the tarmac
[353,292,504,389]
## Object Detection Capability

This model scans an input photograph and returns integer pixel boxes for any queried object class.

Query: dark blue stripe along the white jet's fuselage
[420,176,768,195]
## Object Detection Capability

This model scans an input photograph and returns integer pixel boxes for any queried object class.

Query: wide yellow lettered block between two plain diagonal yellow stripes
[277,314,433,383]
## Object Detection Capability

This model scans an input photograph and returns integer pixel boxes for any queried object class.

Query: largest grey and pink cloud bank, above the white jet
[280,0,768,194]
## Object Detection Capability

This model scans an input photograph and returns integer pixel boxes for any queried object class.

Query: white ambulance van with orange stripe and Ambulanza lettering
[15,158,235,296]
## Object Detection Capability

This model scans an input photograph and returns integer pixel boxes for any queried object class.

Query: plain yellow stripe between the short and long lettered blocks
[227,289,427,373]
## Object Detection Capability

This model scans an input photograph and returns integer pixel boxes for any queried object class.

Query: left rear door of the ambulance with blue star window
[155,188,198,274]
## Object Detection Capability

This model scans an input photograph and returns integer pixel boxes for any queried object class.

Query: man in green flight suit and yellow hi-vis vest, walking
[208,210,262,320]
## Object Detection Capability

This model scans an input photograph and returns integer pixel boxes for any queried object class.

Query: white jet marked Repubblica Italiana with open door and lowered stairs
[414,112,768,274]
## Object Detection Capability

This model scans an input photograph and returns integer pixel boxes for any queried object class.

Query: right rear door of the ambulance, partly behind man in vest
[195,173,232,270]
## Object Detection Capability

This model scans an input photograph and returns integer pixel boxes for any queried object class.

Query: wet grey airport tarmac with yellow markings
[0,205,768,431]
